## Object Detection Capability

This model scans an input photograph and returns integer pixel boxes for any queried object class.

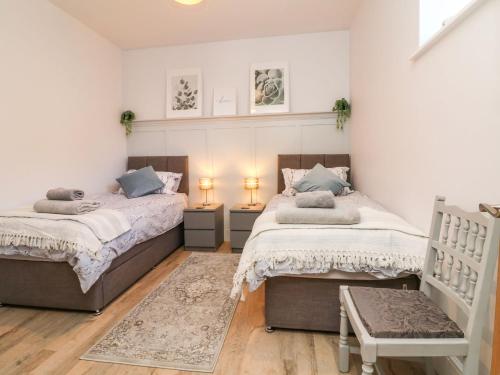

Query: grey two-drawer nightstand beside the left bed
[184,203,224,251]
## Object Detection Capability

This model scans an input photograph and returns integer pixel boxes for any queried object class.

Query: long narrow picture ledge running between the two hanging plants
[133,112,337,127]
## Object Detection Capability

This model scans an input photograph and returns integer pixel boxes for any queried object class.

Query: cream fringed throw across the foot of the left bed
[0,208,130,259]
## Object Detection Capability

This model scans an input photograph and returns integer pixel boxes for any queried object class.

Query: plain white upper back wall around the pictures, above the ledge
[123,31,349,120]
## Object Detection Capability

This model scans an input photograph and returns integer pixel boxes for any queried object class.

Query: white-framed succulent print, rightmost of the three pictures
[250,63,290,113]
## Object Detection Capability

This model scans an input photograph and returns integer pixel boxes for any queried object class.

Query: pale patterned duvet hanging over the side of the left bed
[0,193,188,293]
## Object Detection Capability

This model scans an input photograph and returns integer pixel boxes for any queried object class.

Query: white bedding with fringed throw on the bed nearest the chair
[232,192,427,296]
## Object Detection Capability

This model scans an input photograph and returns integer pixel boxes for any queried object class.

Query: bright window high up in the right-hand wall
[411,0,486,60]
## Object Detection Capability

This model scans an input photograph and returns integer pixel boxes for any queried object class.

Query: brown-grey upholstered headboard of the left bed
[127,156,189,194]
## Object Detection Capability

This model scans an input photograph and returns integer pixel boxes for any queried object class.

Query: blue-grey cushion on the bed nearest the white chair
[293,163,351,194]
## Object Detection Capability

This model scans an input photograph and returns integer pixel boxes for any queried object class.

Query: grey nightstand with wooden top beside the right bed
[229,203,265,253]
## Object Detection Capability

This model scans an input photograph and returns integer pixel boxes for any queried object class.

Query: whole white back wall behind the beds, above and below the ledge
[123,31,350,235]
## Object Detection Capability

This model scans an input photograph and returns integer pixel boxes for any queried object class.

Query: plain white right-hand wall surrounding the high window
[351,0,500,373]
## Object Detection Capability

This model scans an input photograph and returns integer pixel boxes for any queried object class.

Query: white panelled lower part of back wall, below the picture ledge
[128,114,350,240]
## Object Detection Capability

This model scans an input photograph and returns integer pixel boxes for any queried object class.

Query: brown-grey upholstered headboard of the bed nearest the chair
[278,154,351,194]
